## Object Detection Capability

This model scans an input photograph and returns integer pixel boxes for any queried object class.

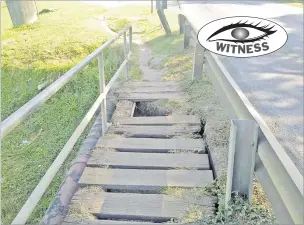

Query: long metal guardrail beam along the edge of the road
[179,15,304,224]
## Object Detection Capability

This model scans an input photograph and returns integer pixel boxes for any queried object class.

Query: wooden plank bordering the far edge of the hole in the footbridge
[118,92,185,102]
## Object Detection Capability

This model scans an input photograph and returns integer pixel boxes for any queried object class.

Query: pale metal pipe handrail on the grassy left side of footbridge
[1,25,132,225]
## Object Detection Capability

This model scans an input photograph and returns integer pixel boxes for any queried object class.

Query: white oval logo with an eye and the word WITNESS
[198,16,287,57]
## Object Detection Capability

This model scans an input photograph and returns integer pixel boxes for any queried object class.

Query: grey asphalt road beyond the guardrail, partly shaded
[179,0,303,174]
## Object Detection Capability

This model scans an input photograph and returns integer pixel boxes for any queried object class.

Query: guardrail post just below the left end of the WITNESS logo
[192,41,205,80]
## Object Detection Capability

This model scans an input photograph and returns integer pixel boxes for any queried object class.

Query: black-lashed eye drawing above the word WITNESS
[207,21,276,43]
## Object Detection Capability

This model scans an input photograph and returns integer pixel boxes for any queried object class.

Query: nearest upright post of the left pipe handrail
[98,52,107,136]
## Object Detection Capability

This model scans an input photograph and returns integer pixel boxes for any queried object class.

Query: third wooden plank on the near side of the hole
[96,136,206,153]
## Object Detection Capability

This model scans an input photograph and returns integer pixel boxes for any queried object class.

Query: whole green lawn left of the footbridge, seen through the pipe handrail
[1,2,141,224]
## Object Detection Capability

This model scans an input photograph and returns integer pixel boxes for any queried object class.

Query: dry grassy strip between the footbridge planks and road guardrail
[144,28,274,224]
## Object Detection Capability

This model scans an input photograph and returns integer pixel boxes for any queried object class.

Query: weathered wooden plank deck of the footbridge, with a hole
[65,82,216,224]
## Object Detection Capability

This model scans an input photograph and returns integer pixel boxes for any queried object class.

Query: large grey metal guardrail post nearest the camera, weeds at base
[225,120,259,208]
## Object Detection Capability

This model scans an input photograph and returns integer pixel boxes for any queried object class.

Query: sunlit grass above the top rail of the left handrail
[1,2,108,119]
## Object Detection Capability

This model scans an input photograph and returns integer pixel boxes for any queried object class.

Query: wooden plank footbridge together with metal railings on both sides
[0,21,303,225]
